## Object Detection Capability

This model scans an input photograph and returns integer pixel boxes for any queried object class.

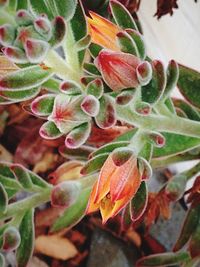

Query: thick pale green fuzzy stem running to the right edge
[116,105,200,138]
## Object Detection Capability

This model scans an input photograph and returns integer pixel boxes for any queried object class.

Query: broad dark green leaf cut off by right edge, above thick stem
[178,64,200,108]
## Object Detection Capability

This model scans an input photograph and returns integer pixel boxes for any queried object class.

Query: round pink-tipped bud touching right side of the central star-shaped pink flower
[81,95,99,117]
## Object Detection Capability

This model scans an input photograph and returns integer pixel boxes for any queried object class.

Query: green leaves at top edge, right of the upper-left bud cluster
[29,0,77,20]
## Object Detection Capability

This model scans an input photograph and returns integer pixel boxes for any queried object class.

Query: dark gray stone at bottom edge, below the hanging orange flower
[87,229,138,267]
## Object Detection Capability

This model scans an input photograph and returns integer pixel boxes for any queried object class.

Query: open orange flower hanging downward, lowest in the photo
[87,148,141,223]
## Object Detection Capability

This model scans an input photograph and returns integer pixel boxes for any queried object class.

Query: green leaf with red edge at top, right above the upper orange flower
[110,0,138,30]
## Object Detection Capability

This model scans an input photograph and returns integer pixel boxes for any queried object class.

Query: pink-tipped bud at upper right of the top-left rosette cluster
[34,17,52,40]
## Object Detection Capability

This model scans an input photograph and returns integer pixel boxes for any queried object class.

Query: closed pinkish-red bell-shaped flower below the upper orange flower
[95,49,143,91]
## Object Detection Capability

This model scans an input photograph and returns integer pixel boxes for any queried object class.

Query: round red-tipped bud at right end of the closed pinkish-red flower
[136,61,152,86]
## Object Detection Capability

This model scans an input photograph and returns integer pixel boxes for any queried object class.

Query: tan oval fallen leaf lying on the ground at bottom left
[35,235,78,260]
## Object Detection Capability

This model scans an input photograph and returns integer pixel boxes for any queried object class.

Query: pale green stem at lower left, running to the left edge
[0,188,51,223]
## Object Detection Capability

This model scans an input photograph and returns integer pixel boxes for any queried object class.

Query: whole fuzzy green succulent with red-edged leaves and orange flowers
[0,0,200,267]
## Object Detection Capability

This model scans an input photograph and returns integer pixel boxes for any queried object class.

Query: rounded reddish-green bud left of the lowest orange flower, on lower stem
[51,181,81,208]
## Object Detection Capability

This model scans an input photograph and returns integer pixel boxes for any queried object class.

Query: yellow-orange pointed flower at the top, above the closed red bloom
[87,11,121,51]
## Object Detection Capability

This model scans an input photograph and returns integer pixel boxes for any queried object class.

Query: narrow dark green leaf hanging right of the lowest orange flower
[130,181,148,221]
